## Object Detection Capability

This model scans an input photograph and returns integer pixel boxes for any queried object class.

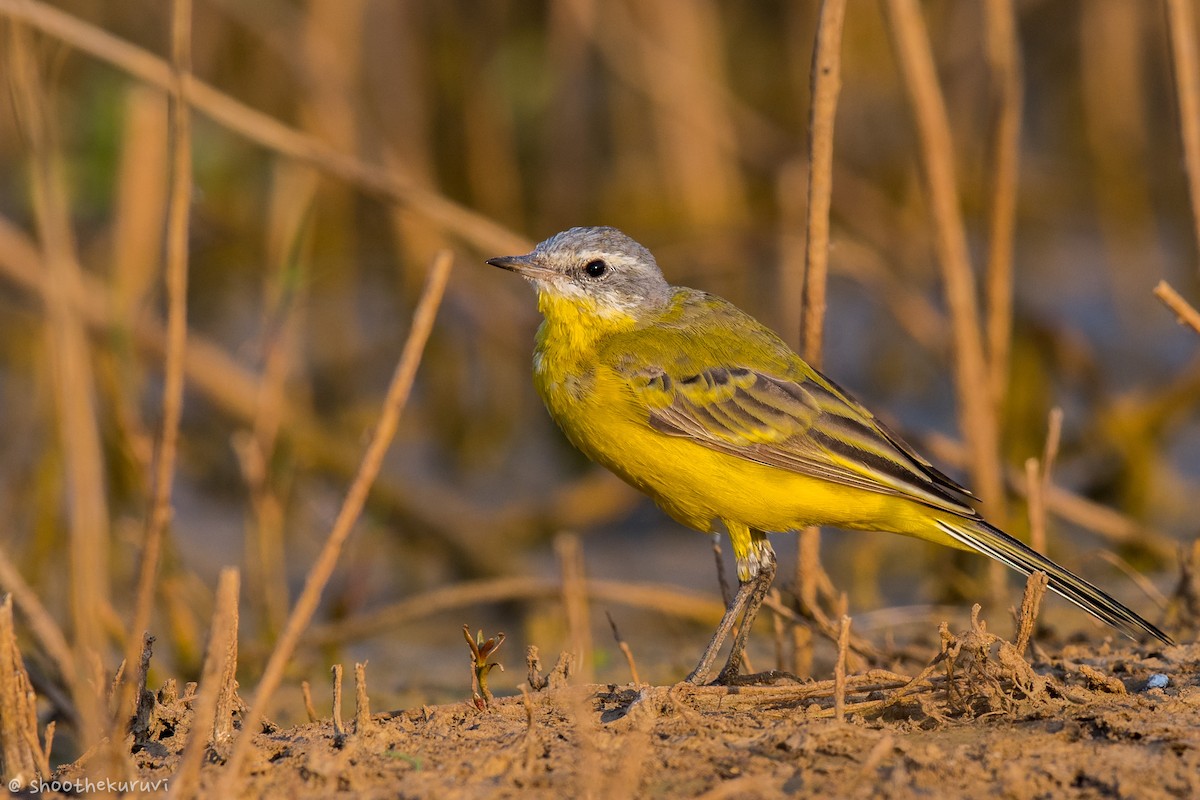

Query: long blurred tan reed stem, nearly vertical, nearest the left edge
[7,24,109,750]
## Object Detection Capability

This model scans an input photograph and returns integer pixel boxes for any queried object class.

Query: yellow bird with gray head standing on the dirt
[486,227,1172,685]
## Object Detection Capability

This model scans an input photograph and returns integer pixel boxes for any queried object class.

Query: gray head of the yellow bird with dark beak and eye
[487,228,671,314]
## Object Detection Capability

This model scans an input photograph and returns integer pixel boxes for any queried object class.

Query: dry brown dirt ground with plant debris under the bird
[56,625,1200,799]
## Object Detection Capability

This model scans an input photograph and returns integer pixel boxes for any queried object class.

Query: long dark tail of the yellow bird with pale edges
[937,519,1175,644]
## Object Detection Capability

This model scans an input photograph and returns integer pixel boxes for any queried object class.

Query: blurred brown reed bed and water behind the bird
[0,0,1200,743]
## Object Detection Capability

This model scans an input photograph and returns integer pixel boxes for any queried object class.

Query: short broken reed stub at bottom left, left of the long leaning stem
[168,567,241,798]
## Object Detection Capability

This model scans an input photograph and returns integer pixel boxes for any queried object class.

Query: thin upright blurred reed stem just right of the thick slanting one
[984,0,1025,410]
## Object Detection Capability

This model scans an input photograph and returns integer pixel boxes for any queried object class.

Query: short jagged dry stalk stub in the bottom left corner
[0,594,50,788]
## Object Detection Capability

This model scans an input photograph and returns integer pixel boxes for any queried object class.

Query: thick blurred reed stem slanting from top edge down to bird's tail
[884,0,1004,537]
